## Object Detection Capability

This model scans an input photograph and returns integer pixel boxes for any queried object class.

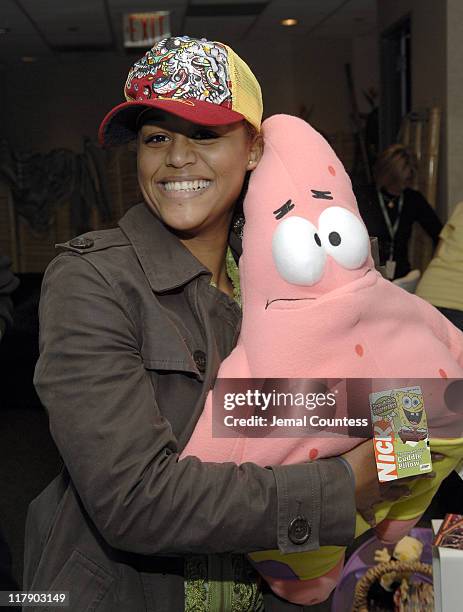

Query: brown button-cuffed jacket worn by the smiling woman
[24,205,355,612]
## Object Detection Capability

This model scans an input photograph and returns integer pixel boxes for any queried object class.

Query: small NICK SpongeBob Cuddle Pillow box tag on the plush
[370,387,432,482]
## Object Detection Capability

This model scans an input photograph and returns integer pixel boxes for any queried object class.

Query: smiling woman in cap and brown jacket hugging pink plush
[24,37,412,612]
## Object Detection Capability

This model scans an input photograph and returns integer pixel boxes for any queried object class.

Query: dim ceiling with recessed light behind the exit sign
[0,0,376,67]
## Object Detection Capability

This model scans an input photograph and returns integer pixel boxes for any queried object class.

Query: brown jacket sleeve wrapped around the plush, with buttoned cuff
[35,254,355,554]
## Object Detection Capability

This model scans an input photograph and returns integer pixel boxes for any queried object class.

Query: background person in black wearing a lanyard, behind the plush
[355,144,442,280]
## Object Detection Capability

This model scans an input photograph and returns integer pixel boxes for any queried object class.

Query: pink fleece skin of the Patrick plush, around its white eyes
[182,115,463,465]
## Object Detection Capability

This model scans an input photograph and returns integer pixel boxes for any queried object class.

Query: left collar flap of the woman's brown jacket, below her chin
[119,204,211,293]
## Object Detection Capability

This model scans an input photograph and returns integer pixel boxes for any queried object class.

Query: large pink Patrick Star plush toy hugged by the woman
[183,115,463,605]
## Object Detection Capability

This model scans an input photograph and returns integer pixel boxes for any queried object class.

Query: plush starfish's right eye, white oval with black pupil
[318,206,370,270]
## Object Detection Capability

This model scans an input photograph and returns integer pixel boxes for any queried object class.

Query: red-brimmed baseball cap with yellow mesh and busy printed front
[99,36,263,146]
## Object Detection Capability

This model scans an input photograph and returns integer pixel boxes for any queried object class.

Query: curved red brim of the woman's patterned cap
[98,98,244,147]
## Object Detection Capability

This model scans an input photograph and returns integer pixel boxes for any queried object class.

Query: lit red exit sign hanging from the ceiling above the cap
[124,11,170,48]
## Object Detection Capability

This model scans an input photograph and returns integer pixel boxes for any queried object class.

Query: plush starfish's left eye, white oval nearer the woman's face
[272,217,326,285]
